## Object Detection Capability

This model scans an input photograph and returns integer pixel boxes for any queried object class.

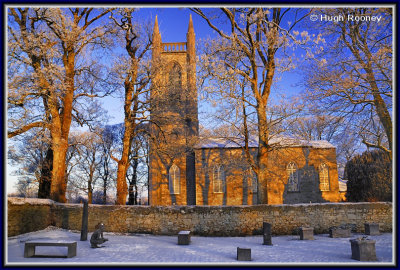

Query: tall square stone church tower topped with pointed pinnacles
[149,16,199,205]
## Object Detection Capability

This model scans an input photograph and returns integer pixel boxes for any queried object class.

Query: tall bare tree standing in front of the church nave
[192,8,310,203]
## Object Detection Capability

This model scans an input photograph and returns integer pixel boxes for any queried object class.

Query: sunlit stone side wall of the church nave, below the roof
[195,146,340,205]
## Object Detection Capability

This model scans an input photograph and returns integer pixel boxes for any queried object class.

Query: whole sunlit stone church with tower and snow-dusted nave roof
[149,17,340,205]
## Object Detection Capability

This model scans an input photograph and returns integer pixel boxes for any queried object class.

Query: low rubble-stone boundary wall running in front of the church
[8,198,393,236]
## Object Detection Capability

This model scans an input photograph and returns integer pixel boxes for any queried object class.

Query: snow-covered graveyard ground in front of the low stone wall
[6,227,394,266]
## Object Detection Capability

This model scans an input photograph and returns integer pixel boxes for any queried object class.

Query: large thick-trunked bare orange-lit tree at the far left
[8,8,112,202]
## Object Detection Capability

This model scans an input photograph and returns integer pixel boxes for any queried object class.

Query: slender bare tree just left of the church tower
[111,8,151,205]
